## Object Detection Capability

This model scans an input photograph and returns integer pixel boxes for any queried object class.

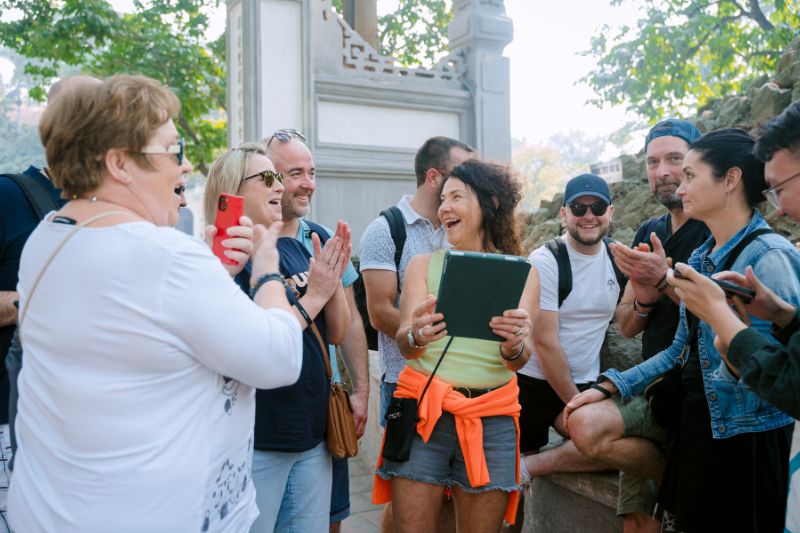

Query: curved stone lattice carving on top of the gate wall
[321,0,466,81]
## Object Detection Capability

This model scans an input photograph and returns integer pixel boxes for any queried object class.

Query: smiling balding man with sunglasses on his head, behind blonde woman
[266,128,369,533]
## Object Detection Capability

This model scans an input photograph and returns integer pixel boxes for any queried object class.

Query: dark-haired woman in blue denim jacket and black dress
[567,129,800,532]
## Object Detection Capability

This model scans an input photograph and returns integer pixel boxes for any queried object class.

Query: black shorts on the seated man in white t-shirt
[517,373,591,454]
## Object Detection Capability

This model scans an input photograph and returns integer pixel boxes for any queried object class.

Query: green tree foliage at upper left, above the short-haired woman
[0,0,226,173]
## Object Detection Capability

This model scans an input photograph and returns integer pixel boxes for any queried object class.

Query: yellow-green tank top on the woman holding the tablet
[406,250,514,389]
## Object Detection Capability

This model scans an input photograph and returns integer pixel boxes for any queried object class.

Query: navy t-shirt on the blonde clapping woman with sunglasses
[236,237,330,453]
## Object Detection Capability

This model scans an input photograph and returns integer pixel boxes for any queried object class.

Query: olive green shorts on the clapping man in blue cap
[612,395,671,516]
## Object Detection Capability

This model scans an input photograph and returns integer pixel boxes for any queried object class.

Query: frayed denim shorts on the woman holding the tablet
[377,412,520,493]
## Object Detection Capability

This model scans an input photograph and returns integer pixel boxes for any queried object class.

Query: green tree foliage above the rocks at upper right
[581,0,800,121]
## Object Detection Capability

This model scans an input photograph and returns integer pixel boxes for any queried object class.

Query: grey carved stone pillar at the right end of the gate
[448,0,514,163]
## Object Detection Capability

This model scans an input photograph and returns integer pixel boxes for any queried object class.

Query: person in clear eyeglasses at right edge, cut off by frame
[670,102,800,533]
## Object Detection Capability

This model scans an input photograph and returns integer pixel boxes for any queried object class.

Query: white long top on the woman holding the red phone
[8,218,302,533]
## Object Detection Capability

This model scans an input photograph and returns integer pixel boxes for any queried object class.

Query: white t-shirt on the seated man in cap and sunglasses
[520,237,619,383]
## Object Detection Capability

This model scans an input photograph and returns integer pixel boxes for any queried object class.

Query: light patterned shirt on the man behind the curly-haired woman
[359,195,447,383]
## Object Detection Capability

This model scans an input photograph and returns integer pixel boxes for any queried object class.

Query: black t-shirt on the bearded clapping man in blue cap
[631,213,710,360]
